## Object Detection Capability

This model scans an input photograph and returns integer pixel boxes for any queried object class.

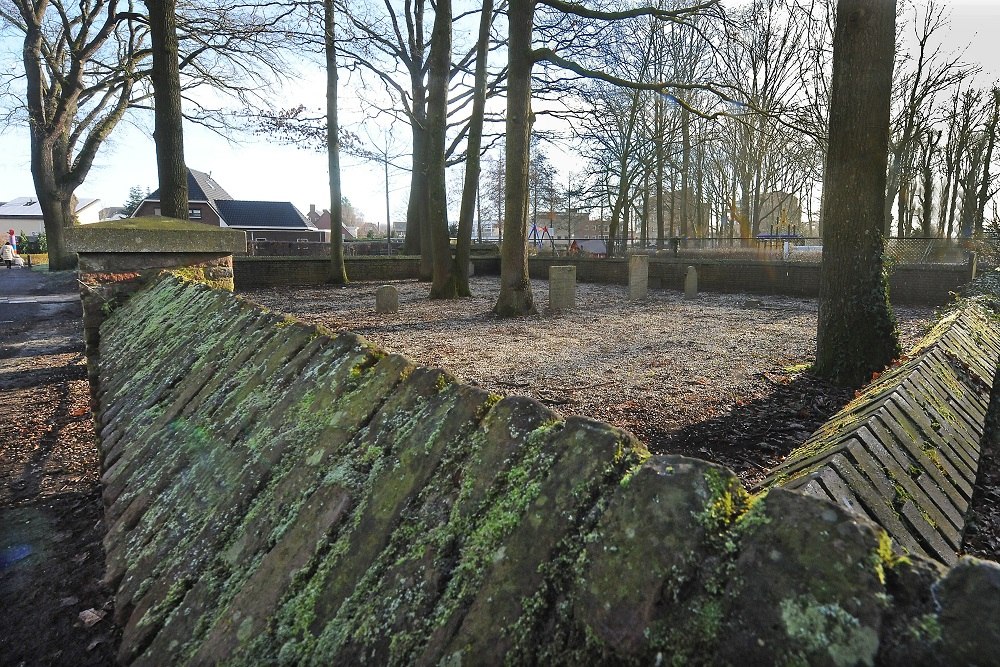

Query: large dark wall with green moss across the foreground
[96,275,1000,665]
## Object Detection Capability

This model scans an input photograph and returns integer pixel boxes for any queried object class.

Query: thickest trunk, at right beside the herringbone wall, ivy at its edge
[816,0,900,386]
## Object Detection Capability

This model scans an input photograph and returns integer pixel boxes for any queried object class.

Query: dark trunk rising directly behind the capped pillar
[145,0,188,220]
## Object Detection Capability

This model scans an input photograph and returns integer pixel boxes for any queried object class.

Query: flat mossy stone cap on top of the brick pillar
[66,217,247,254]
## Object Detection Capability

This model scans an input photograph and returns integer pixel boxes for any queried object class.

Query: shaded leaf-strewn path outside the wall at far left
[0,265,117,665]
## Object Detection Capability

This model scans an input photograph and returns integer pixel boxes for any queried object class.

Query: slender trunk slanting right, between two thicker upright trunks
[454,0,493,296]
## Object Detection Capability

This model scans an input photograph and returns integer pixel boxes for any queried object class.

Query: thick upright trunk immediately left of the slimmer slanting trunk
[427,0,458,299]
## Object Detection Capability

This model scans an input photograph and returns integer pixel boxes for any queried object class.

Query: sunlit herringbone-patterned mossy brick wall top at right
[766,296,1000,563]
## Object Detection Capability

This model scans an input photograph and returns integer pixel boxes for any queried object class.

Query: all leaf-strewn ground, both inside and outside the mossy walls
[0,270,1000,665]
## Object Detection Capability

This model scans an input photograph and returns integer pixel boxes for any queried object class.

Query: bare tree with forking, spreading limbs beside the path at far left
[0,0,146,270]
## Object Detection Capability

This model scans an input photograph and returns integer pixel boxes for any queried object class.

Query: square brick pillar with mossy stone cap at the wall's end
[66,218,246,402]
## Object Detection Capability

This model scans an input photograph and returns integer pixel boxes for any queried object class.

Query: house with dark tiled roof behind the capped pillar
[132,168,327,243]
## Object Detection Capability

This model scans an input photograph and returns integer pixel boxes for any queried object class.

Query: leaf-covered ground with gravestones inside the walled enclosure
[243,277,934,486]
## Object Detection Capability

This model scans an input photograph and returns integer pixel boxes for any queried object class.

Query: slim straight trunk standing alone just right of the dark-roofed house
[323,0,348,285]
